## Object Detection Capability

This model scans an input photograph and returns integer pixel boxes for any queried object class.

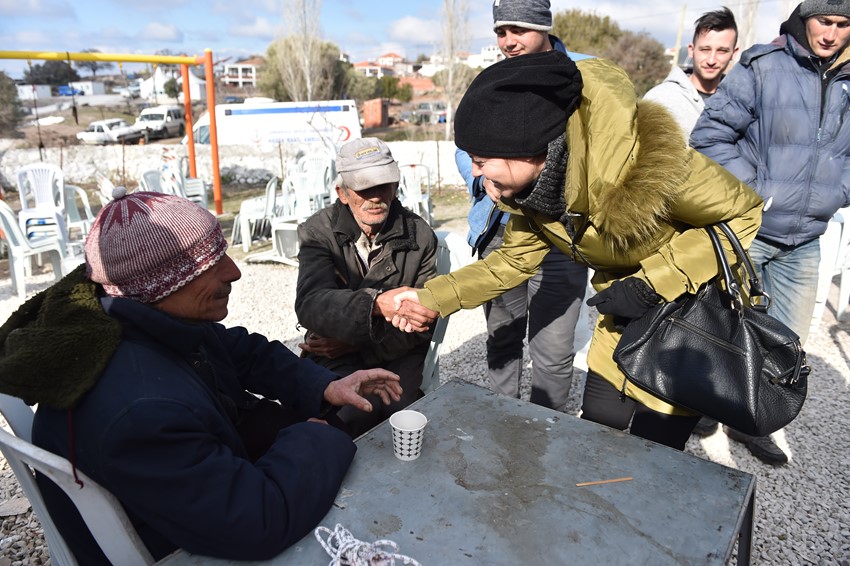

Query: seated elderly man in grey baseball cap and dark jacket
[295,138,437,437]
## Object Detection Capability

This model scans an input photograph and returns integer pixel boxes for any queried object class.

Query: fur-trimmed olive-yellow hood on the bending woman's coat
[502,59,691,260]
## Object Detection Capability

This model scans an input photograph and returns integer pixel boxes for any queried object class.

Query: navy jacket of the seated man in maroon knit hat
[0,270,355,564]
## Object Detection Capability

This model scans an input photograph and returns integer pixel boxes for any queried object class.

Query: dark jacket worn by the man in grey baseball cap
[295,199,437,368]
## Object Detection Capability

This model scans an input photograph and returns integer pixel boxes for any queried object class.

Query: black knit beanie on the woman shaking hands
[455,50,582,157]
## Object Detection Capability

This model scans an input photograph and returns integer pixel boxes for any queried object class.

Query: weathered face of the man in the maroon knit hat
[153,254,242,322]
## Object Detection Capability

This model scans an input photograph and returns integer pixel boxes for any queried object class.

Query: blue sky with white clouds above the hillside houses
[0,0,796,78]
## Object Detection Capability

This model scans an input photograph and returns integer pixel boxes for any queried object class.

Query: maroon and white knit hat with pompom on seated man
[86,187,227,303]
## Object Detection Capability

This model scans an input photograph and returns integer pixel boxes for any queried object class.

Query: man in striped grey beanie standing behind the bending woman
[455,0,587,418]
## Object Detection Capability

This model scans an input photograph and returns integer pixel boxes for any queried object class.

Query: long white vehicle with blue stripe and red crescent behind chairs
[183,99,361,146]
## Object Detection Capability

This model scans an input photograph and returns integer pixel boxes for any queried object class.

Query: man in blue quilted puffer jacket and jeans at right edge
[691,0,850,465]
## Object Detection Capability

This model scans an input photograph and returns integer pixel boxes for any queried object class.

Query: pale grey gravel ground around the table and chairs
[0,236,850,566]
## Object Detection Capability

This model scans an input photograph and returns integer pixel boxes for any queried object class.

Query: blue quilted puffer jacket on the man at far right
[691,8,850,246]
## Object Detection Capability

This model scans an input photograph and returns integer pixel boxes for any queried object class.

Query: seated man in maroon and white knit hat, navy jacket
[0,188,401,565]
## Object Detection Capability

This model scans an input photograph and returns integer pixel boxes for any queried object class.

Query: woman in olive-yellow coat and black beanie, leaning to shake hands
[396,51,762,450]
